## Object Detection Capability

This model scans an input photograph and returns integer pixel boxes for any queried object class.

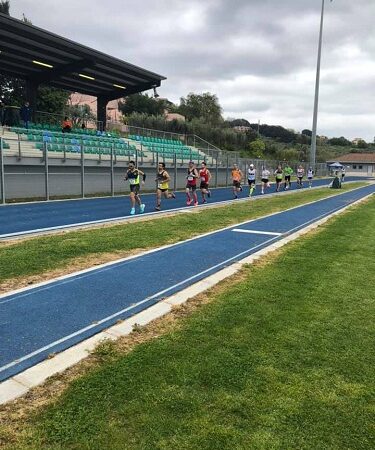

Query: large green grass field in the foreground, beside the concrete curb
[0,189,375,450]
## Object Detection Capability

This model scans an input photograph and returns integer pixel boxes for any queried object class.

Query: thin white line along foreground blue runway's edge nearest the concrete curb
[0,236,278,373]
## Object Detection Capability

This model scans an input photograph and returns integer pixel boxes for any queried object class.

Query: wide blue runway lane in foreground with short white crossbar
[0,185,375,381]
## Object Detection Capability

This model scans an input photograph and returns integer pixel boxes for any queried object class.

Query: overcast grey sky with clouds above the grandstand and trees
[10,0,375,141]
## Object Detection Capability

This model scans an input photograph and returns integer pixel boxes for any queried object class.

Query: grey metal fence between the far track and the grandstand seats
[0,137,328,204]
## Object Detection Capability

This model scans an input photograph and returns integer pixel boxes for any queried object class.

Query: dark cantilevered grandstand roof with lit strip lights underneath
[0,14,165,100]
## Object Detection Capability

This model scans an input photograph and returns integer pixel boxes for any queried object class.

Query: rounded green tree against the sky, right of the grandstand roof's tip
[178,92,223,125]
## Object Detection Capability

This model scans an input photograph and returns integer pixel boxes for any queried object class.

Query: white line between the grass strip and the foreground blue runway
[0,186,368,305]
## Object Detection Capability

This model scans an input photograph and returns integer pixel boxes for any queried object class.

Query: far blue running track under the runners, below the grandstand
[0,177,366,239]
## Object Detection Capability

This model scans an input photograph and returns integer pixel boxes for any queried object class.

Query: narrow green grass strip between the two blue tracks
[0,183,366,283]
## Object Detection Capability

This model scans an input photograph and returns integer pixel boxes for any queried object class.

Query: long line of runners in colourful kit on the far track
[124,161,314,215]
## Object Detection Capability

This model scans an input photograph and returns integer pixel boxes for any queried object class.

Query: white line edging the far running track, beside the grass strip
[0,181,364,240]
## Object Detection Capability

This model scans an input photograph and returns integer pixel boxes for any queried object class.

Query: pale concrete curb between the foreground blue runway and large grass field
[0,188,373,405]
